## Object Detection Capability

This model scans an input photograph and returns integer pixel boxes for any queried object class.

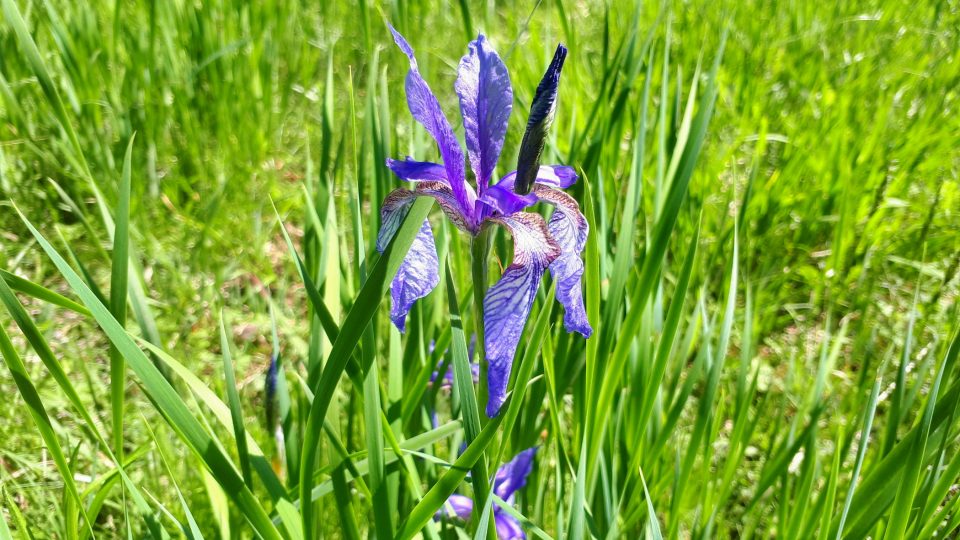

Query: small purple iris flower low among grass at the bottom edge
[437,447,537,540]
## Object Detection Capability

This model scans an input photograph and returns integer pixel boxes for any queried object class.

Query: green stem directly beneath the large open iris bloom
[470,227,497,540]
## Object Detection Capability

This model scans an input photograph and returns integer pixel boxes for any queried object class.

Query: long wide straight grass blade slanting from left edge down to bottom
[14,206,281,540]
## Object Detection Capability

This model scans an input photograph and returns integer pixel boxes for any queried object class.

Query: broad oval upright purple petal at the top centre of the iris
[455,34,513,190]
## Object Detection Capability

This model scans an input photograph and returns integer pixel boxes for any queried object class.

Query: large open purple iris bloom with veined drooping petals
[377,27,592,417]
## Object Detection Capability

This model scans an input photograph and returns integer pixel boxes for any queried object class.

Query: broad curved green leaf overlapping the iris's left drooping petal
[300,197,433,538]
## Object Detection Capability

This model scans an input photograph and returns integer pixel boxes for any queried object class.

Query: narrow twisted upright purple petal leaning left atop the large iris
[390,26,477,222]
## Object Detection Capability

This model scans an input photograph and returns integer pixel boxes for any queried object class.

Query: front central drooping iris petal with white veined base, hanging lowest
[483,213,560,418]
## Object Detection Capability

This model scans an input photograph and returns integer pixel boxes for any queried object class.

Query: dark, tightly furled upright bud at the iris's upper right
[516,45,567,195]
